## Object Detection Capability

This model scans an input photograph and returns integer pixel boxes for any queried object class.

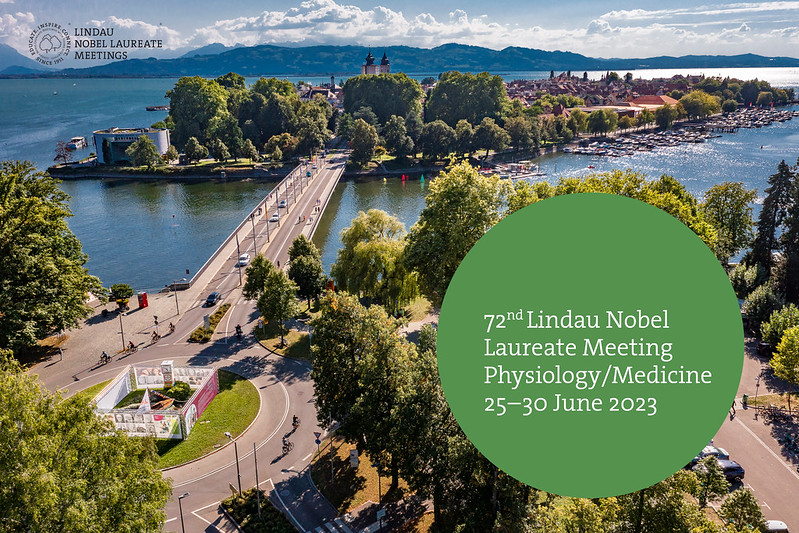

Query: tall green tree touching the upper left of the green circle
[405,163,510,306]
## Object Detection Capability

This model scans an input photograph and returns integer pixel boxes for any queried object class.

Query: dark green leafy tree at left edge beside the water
[0,161,105,349]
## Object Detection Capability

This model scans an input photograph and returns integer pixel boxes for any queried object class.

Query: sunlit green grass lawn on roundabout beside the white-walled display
[156,370,260,468]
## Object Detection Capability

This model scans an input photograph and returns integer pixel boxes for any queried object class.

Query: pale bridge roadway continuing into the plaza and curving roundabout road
[31,150,348,531]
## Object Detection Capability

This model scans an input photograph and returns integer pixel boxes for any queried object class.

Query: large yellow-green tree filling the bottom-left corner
[0,358,172,533]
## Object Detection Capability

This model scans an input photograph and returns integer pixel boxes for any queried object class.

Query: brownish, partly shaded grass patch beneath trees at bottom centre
[311,437,408,513]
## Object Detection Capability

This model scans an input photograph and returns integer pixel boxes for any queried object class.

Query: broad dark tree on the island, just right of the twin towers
[426,72,508,127]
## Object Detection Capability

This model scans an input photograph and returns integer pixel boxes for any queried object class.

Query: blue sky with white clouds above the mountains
[0,0,799,66]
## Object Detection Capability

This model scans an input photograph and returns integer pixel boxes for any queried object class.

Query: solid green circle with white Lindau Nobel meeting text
[438,194,744,498]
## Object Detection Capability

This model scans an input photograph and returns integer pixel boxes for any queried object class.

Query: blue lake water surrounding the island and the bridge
[0,69,799,290]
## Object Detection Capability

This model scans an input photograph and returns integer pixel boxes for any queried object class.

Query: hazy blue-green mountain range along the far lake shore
[0,44,799,78]
